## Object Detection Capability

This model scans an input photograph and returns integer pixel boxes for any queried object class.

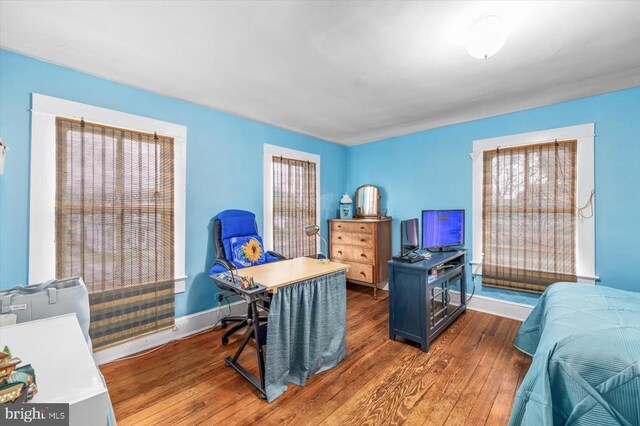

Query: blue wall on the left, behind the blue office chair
[0,50,347,316]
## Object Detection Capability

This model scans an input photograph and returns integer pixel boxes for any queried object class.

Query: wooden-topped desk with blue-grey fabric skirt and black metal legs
[211,257,348,402]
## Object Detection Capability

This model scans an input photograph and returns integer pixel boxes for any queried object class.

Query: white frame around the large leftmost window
[29,93,187,293]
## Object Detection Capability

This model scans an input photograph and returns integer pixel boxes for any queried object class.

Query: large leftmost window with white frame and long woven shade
[29,94,185,350]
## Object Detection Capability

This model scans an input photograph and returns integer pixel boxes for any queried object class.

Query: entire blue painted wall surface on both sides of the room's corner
[0,50,640,316]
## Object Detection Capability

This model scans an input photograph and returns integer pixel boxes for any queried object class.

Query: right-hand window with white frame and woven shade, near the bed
[472,125,597,293]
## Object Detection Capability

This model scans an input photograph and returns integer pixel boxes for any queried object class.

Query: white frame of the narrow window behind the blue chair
[262,143,322,250]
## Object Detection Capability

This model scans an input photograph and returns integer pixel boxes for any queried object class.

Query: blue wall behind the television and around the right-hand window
[347,88,640,303]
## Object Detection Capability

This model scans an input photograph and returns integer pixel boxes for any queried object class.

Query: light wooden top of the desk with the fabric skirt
[237,257,349,293]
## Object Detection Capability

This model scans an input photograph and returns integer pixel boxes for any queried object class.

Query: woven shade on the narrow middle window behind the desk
[272,157,317,258]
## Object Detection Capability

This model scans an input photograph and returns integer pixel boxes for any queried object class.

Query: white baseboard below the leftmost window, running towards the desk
[93,301,247,365]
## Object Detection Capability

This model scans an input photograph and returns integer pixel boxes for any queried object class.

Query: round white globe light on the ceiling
[467,15,507,59]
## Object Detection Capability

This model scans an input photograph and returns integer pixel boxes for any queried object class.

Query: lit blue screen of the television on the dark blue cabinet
[422,210,464,250]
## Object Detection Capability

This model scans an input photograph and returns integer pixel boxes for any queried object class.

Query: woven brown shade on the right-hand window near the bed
[482,140,577,293]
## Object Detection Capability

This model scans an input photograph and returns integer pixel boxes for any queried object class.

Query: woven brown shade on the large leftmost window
[56,118,174,349]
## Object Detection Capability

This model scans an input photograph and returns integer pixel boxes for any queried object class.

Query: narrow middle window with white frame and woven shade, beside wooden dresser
[264,145,320,258]
